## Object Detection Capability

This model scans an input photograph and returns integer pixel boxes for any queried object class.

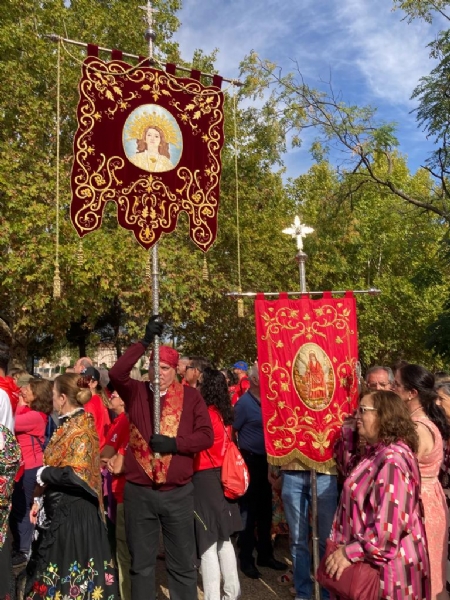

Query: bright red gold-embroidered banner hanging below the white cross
[255,292,358,470]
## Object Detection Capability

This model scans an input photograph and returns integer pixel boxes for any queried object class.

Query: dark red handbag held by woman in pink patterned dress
[316,539,380,600]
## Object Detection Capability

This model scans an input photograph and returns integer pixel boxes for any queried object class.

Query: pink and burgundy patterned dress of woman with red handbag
[331,428,431,600]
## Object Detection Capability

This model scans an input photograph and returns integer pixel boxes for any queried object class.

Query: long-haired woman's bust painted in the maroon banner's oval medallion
[130,125,174,173]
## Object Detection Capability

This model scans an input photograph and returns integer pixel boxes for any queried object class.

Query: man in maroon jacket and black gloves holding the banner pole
[109,316,214,600]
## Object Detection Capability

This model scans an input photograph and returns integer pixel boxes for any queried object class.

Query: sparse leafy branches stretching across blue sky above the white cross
[242,53,450,222]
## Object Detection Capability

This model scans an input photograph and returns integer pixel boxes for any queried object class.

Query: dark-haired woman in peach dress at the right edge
[394,364,450,599]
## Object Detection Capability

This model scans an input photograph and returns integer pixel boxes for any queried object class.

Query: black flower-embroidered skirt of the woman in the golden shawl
[25,496,118,600]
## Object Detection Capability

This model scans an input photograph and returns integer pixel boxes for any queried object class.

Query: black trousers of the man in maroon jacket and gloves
[123,482,197,600]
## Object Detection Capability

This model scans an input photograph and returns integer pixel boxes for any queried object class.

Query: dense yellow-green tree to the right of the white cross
[291,160,450,367]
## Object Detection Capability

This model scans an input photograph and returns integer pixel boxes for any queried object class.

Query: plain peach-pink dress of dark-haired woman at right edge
[412,416,448,600]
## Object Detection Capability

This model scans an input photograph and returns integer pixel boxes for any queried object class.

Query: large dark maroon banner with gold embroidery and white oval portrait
[70,56,224,251]
